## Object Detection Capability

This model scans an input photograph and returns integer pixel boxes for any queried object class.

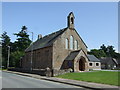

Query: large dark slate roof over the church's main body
[25,28,67,52]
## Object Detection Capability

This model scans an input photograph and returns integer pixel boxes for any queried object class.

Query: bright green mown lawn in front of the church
[57,71,120,86]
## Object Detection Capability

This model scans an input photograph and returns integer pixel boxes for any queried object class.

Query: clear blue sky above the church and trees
[2,2,118,51]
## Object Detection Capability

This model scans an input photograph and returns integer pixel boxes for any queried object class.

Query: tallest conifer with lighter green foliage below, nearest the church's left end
[10,26,31,67]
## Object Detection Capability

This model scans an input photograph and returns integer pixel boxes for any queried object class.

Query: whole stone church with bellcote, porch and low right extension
[22,12,101,76]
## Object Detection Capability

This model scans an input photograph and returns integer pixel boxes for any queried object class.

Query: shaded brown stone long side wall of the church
[22,47,52,69]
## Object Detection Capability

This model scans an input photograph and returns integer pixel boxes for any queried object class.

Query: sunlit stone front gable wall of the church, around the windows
[53,28,87,70]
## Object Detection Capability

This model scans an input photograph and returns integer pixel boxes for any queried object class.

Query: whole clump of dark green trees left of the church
[1,26,31,68]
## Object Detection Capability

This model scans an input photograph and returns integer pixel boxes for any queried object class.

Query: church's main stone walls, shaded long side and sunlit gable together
[22,28,87,72]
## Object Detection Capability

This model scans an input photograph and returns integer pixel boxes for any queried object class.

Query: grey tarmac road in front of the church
[2,72,82,88]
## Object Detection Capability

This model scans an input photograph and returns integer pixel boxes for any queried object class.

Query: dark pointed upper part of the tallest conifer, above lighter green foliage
[14,26,31,51]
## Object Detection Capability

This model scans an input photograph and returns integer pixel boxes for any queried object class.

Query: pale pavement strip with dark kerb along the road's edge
[3,71,120,90]
